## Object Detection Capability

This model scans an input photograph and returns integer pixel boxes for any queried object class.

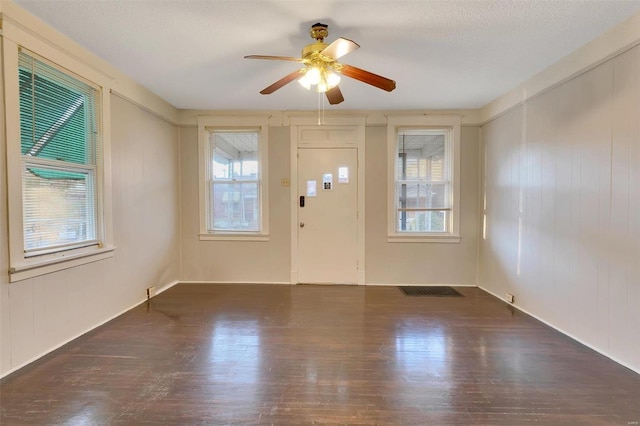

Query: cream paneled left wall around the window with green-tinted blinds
[0,96,179,375]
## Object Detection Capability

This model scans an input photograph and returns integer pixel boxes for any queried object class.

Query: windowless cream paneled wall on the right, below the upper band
[479,42,640,371]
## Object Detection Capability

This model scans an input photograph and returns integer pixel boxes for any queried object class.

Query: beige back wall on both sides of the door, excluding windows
[180,126,479,285]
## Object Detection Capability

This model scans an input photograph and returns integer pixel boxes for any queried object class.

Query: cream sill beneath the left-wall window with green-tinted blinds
[9,246,116,283]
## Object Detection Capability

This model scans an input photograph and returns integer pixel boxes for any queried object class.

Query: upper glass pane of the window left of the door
[211,132,258,180]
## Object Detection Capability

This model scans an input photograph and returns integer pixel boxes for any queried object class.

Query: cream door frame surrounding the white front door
[289,114,366,285]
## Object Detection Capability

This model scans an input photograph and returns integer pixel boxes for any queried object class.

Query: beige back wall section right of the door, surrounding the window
[365,127,479,285]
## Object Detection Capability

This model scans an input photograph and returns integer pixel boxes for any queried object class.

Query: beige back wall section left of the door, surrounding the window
[180,127,291,283]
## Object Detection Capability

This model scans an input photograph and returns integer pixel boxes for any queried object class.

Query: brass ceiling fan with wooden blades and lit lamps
[245,23,396,105]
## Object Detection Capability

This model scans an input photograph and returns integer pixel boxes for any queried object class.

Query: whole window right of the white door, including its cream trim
[387,116,460,242]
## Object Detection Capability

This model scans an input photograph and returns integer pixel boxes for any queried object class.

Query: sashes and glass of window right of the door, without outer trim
[395,129,452,233]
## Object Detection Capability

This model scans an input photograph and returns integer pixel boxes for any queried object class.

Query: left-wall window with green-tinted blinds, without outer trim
[18,52,100,257]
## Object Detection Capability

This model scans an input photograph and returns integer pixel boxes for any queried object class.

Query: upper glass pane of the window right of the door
[397,130,448,180]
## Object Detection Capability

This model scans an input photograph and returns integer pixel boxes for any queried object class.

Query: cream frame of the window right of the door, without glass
[387,115,461,243]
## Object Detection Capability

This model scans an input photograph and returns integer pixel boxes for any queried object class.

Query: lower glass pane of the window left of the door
[211,181,260,231]
